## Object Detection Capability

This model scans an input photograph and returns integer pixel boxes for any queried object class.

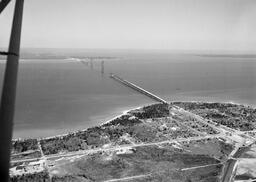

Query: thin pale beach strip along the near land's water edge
[12,100,256,141]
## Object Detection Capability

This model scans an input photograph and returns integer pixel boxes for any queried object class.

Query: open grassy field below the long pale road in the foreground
[51,139,229,182]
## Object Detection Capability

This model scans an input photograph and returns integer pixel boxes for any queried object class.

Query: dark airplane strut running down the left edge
[0,0,24,182]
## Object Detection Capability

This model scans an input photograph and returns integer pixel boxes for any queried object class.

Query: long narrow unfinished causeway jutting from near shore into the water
[110,73,168,104]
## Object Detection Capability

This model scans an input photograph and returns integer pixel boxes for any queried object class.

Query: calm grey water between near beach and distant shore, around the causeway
[0,53,256,138]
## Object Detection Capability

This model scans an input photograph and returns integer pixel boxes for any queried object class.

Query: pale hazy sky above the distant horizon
[0,0,256,51]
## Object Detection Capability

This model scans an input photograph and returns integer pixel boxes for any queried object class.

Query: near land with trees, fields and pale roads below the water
[10,102,256,182]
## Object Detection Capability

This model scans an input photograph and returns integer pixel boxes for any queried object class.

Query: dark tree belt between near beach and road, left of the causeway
[13,104,168,155]
